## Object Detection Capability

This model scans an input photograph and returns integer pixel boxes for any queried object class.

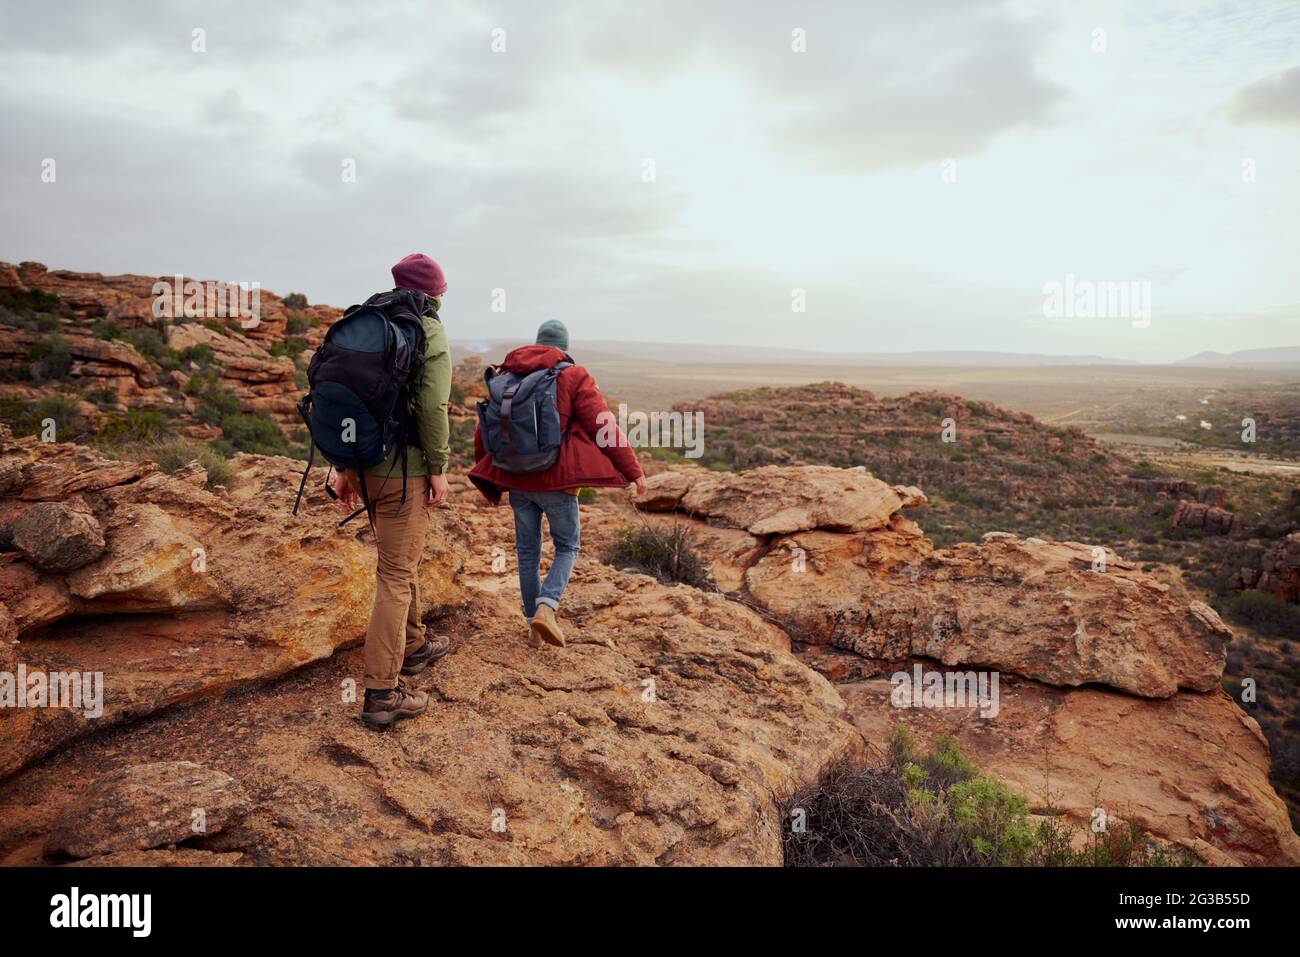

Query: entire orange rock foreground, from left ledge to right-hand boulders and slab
[0,432,1300,865]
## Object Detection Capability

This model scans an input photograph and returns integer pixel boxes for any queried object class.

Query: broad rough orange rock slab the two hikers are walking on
[0,504,861,865]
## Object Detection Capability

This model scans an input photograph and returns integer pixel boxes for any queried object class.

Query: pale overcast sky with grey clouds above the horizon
[0,0,1300,361]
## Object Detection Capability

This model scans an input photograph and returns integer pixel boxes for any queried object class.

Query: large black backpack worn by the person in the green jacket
[294,289,437,524]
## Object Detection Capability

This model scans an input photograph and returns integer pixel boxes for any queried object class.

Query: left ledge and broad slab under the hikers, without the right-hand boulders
[0,439,863,865]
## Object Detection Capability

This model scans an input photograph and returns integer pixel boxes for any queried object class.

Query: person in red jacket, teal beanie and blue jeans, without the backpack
[469,320,646,648]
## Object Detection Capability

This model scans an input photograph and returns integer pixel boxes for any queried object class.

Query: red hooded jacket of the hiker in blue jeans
[469,346,644,505]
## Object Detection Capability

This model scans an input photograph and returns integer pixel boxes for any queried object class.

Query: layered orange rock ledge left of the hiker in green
[0,433,463,776]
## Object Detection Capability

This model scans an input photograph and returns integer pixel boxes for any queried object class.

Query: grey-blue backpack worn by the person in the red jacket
[478,356,573,473]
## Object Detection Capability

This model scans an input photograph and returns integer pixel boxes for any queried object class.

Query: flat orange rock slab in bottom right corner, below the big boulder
[836,677,1300,866]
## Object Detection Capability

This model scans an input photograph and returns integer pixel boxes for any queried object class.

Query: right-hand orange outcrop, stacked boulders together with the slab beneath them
[626,468,1300,863]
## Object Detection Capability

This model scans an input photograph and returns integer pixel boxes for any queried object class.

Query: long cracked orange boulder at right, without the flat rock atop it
[746,536,1232,697]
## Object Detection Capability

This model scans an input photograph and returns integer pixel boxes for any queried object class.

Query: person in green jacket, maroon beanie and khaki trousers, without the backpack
[337,254,451,727]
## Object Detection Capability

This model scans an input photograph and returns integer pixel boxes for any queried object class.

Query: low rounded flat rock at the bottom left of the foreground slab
[46,761,248,858]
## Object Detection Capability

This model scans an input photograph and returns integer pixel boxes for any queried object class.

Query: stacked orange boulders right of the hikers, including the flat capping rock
[634,467,1231,697]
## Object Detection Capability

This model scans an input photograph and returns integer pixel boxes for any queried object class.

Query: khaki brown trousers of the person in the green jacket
[364,475,429,690]
